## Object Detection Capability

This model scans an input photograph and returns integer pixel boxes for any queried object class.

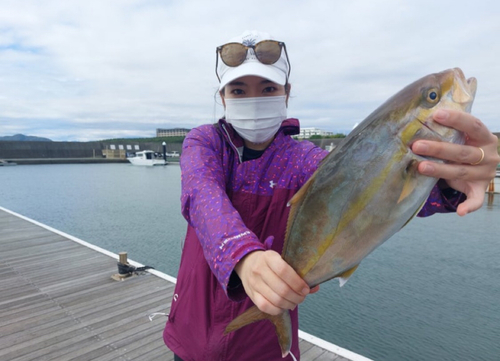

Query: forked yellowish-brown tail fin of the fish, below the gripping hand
[224,306,292,357]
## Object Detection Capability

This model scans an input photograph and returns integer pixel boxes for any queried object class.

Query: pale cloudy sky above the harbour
[0,0,500,141]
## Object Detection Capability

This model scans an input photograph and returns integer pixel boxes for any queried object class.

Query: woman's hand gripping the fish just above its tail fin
[235,250,317,315]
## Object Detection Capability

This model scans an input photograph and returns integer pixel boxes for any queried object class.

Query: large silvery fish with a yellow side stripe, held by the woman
[225,68,477,357]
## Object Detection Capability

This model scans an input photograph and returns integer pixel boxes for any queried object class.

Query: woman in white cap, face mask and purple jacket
[164,31,500,361]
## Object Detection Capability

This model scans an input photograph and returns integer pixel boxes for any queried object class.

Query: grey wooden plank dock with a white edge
[0,207,369,361]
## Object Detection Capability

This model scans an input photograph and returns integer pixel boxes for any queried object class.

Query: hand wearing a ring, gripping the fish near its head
[412,110,500,216]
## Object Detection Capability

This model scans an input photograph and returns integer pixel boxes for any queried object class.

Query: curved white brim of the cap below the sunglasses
[219,61,286,90]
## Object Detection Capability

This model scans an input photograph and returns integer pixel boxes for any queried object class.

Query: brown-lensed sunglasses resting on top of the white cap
[215,40,291,82]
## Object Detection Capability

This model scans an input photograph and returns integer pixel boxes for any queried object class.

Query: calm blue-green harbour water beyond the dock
[0,164,500,361]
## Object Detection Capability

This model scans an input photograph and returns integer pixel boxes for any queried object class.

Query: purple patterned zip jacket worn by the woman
[163,119,459,361]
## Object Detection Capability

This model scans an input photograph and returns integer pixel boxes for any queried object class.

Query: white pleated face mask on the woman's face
[225,95,286,143]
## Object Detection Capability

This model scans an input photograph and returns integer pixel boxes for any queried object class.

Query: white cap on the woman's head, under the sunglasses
[217,30,289,90]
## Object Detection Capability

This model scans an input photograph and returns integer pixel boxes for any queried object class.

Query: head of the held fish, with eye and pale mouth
[410,68,477,144]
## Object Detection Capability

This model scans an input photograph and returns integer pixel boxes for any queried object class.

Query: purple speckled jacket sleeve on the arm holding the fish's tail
[180,125,265,300]
